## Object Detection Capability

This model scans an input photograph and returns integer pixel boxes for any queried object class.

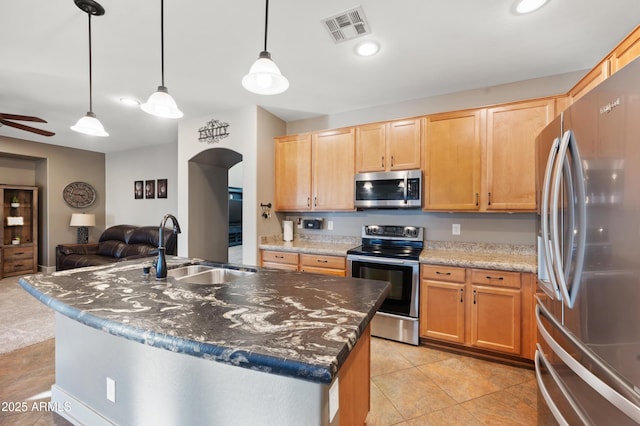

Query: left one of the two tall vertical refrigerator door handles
[538,138,562,300]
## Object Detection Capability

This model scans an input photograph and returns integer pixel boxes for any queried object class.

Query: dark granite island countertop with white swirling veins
[20,257,390,383]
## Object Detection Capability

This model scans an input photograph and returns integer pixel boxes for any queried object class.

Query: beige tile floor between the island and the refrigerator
[369,338,537,426]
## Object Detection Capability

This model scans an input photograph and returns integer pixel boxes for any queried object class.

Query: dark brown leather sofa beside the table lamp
[56,225,178,271]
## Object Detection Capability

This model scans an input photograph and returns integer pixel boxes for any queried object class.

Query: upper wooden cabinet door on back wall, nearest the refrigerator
[488,98,555,211]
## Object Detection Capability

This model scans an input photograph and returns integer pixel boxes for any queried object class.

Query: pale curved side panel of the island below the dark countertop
[52,314,329,425]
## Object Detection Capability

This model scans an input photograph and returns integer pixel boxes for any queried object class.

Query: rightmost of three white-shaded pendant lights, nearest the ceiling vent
[242,0,289,95]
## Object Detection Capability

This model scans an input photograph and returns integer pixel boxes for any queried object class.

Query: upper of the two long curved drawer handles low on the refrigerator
[536,304,640,423]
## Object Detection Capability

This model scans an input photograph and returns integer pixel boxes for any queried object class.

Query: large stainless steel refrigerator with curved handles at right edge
[535,60,640,425]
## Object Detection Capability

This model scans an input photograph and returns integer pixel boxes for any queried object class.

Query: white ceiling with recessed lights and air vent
[0,0,640,152]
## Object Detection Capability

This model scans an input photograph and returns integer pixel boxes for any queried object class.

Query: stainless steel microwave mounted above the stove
[355,170,422,209]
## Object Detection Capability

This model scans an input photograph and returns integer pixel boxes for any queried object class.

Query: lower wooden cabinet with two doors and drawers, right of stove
[420,265,532,358]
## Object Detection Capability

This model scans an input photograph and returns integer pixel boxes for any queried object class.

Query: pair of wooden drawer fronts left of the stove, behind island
[260,250,347,277]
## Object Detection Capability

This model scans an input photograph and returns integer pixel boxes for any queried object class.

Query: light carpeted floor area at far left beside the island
[0,277,55,354]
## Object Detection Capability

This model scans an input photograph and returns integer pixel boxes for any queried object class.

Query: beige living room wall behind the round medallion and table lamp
[0,136,106,270]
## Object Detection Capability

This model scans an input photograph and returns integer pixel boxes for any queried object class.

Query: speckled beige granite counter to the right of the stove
[420,241,538,273]
